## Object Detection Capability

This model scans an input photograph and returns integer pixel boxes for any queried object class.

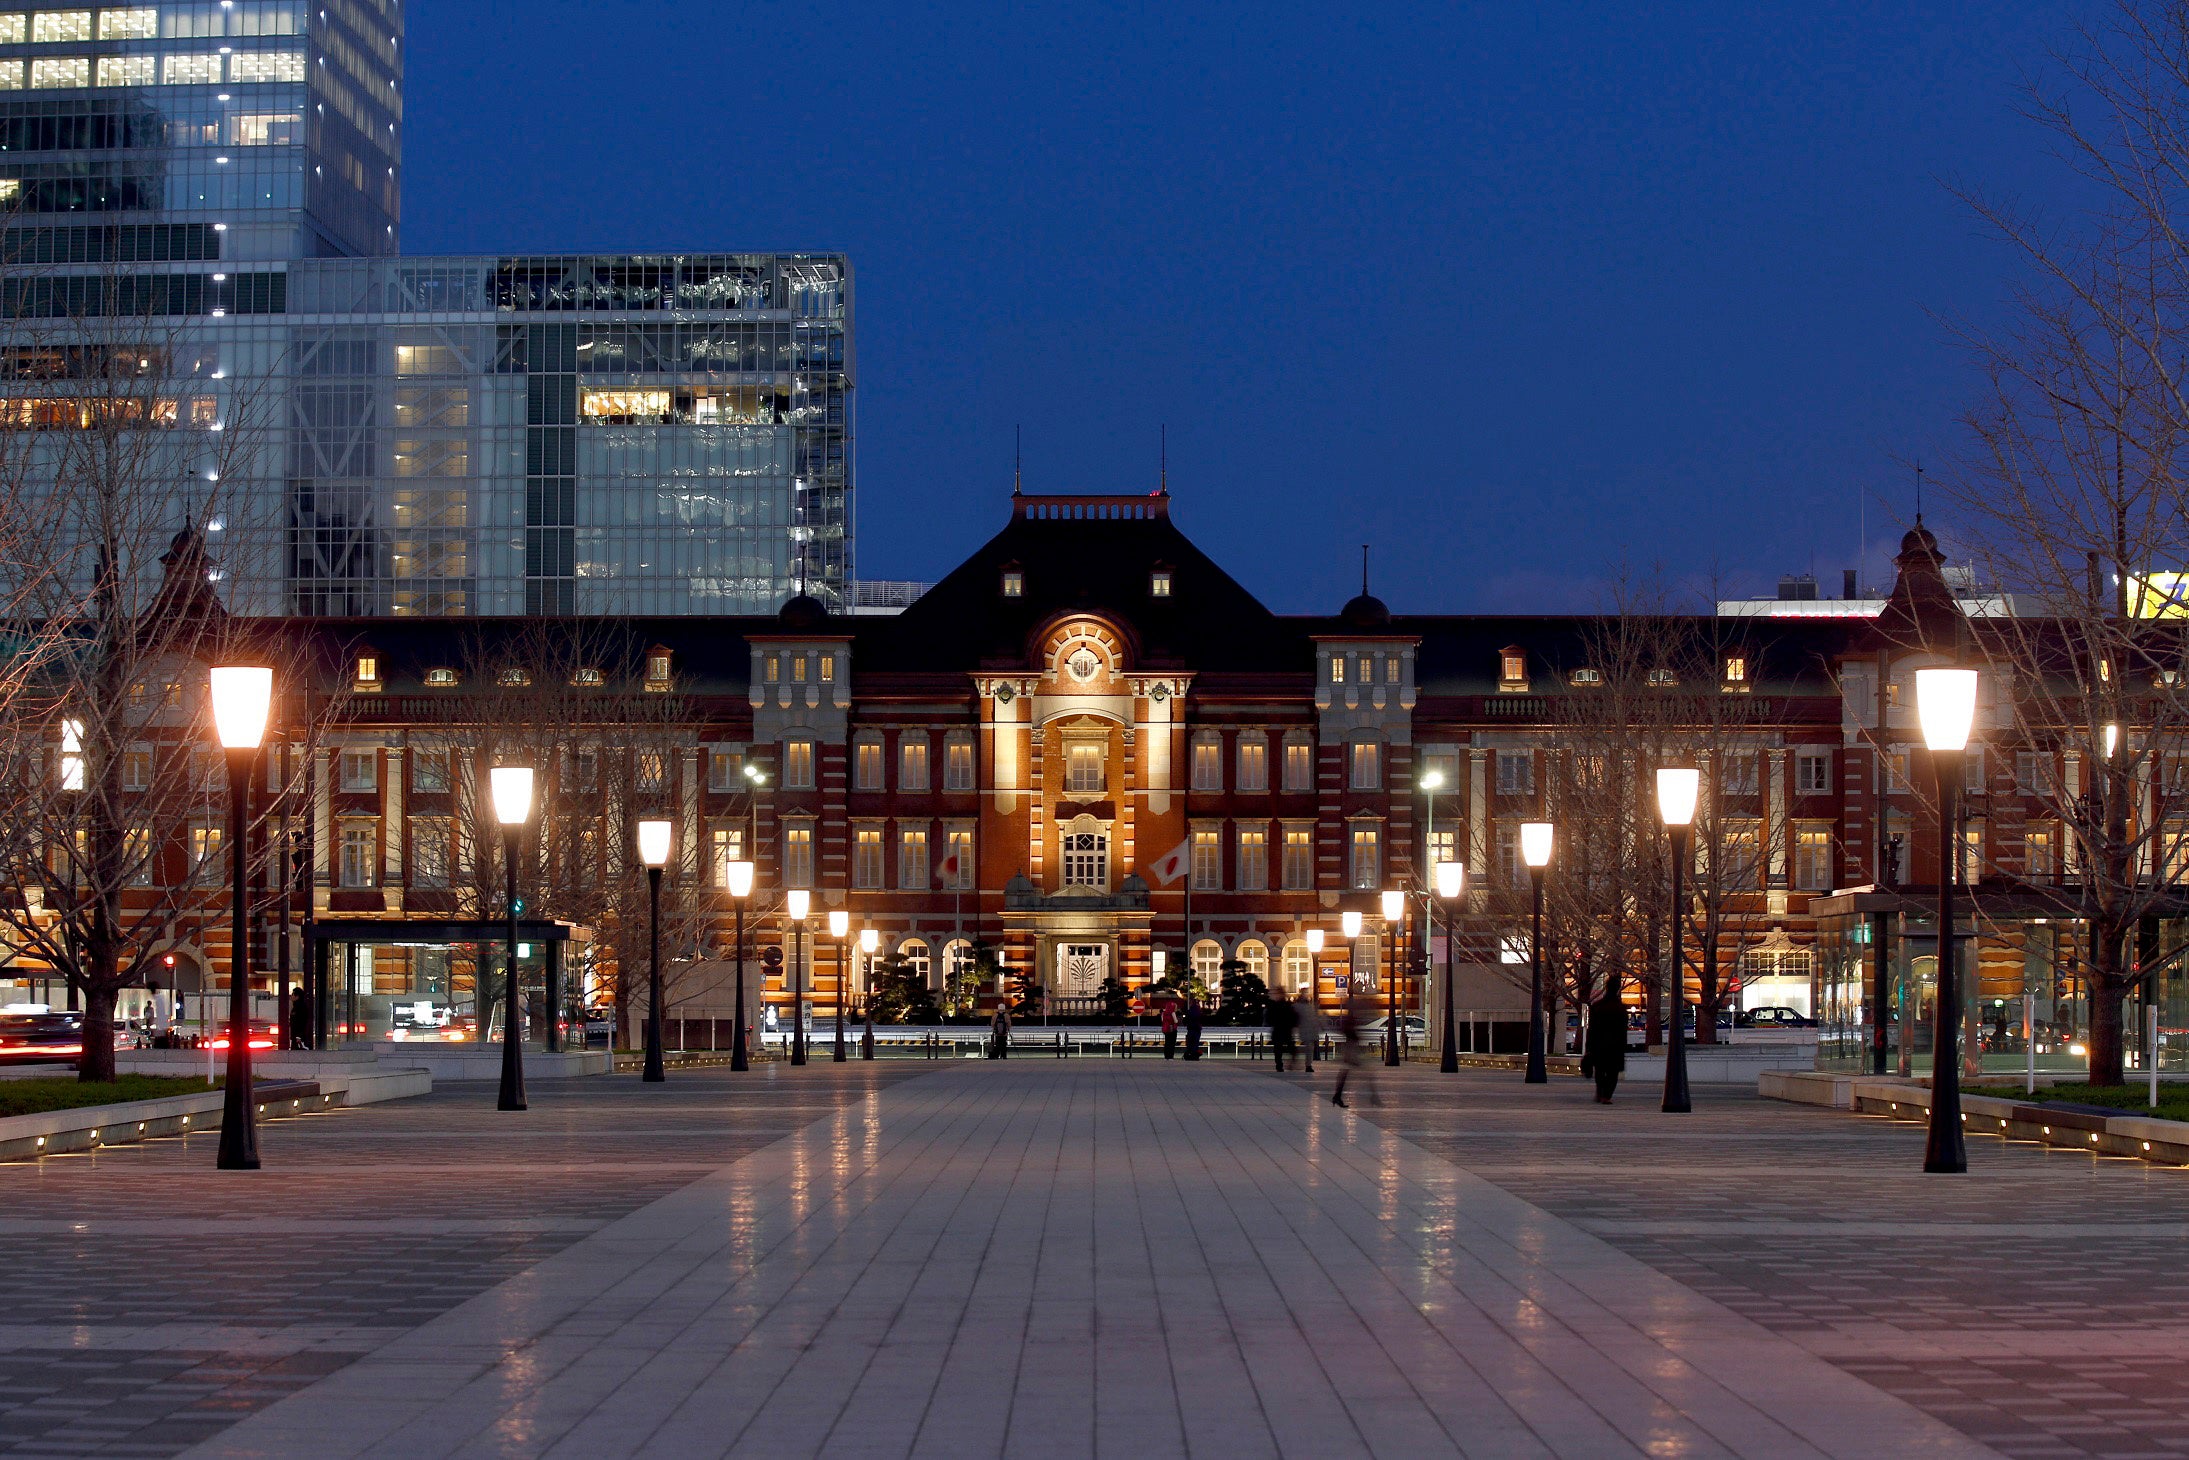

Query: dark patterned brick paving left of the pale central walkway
[0,1064,922,1458]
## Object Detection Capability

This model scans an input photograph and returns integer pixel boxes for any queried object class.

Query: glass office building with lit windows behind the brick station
[0,0,854,617]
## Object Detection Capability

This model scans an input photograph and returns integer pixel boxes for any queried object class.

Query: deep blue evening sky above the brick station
[403,0,2082,611]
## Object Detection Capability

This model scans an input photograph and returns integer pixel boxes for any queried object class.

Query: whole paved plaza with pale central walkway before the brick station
[0,1059,2189,1460]
